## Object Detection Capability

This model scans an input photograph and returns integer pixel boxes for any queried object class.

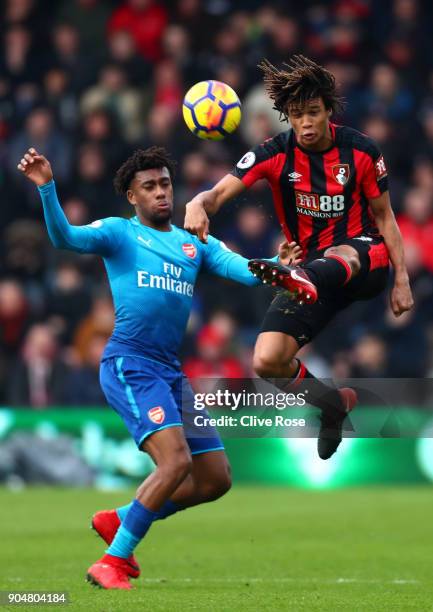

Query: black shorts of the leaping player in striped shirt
[260,236,389,346]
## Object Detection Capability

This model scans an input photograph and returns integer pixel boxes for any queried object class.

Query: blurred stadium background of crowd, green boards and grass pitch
[0,0,433,612]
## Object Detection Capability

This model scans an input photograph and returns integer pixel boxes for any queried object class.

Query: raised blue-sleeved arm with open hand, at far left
[18,148,121,255]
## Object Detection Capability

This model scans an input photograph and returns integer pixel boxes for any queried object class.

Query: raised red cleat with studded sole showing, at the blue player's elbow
[248,259,318,305]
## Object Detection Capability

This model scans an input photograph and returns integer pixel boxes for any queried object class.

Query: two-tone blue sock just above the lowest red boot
[105,499,158,559]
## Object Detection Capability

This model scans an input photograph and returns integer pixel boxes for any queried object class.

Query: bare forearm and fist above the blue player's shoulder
[184,174,245,243]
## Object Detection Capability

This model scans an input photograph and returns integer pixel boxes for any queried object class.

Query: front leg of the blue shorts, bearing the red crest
[100,357,182,448]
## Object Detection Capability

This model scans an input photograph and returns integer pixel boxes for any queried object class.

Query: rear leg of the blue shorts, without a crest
[172,374,224,458]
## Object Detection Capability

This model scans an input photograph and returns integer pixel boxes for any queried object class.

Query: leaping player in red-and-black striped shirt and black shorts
[185,56,413,459]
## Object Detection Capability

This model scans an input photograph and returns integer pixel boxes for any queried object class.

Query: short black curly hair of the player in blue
[113,147,176,195]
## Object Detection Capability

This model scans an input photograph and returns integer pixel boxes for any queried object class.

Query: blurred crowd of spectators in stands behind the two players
[0,0,433,408]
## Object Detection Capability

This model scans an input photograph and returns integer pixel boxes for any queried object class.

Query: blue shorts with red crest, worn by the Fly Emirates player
[100,356,224,455]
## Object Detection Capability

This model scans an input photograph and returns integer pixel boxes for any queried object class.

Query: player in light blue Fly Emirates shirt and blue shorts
[18,147,287,589]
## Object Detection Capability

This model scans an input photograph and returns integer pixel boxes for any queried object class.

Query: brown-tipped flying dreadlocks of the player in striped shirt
[258,55,344,120]
